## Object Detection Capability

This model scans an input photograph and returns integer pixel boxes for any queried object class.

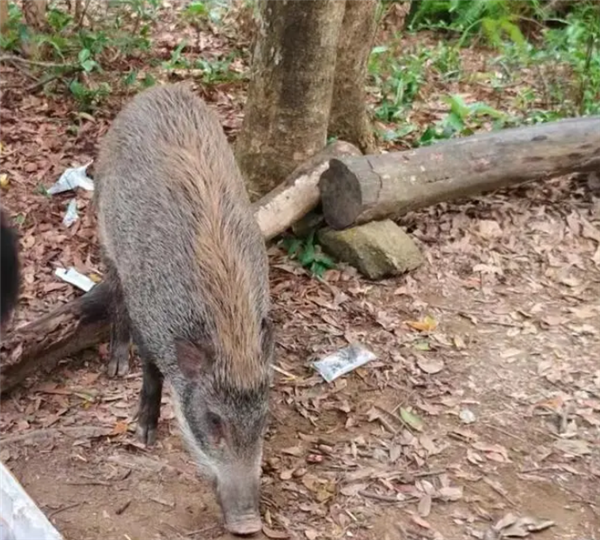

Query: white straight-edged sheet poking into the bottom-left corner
[0,463,64,540]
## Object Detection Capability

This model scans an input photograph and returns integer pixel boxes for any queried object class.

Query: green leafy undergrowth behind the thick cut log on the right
[376,0,600,146]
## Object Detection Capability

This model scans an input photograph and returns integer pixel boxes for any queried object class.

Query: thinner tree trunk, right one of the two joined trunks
[329,0,378,154]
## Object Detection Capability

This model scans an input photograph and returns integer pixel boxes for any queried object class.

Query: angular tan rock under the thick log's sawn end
[319,219,424,279]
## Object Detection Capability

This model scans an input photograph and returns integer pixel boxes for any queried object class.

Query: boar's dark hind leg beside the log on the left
[106,260,130,378]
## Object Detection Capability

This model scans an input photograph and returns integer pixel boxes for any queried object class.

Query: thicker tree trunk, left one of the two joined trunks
[236,0,345,200]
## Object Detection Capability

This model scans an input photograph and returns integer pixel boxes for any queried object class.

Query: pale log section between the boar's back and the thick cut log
[253,141,361,240]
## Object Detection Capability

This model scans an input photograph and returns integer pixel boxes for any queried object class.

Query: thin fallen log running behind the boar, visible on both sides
[0,141,360,394]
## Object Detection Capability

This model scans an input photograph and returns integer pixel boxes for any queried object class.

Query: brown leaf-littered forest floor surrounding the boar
[0,1,600,540]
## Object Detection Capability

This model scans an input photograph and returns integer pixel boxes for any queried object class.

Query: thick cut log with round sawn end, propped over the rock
[319,116,600,229]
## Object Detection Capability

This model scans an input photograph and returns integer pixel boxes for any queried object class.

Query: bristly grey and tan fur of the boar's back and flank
[96,84,270,390]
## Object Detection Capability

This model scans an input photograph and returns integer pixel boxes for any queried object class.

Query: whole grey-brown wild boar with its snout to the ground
[95,84,273,535]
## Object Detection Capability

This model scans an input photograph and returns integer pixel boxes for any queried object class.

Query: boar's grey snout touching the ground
[216,472,262,536]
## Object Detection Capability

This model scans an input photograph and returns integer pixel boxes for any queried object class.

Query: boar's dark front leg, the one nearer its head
[137,352,163,446]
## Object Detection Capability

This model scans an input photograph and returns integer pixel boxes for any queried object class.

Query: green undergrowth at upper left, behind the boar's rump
[0,0,242,110]
